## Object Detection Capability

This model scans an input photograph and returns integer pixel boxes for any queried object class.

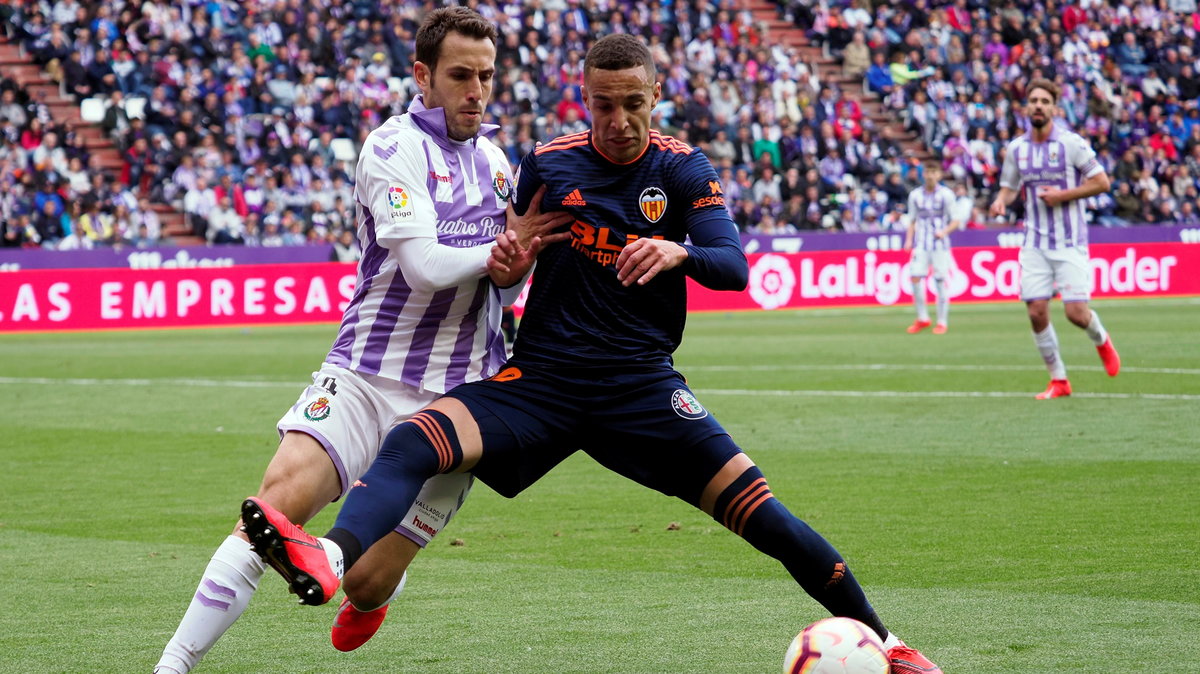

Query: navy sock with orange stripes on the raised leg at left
[325,410,462,570]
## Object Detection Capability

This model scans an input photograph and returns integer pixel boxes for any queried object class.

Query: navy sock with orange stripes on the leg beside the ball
[713,467,888,639]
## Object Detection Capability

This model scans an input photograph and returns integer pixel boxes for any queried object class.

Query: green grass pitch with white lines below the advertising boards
[0,299,1200,674]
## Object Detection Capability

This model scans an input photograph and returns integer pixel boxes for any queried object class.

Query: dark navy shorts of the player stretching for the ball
[446,361,740,504]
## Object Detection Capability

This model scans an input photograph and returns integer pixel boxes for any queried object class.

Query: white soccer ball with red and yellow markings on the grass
[784,618,888,674]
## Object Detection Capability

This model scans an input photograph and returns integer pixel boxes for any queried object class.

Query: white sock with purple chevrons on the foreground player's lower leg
[155,535,266,674]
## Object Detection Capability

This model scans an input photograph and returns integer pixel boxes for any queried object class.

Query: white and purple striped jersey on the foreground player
[326,92,512,393]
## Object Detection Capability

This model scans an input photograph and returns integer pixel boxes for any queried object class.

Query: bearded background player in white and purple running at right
[990,79,1121,399]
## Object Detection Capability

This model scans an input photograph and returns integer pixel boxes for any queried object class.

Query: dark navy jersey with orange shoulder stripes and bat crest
[514,131,749,367]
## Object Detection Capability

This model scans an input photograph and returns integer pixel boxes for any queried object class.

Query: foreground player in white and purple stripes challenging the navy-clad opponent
[155,7,570,673]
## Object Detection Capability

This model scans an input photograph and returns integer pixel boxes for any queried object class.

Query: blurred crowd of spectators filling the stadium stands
[7,0,1200,249]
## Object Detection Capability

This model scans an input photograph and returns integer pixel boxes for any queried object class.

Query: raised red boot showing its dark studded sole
[241,497,342,606]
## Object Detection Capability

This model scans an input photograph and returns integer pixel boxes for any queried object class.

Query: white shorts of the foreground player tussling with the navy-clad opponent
[277,362,474,547]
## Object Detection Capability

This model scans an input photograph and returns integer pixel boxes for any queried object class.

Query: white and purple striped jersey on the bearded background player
[1000,125,1104,251]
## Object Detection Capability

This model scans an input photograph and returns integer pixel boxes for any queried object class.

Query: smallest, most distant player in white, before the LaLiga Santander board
[904,160,961,335]
